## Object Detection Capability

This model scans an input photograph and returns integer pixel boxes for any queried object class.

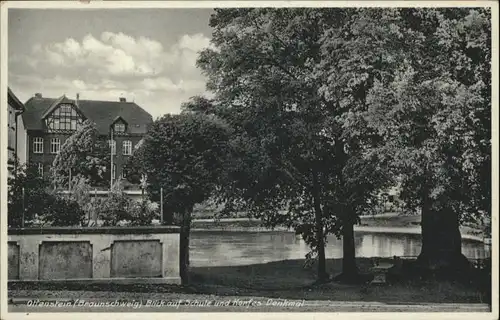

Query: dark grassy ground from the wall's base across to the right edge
[9,259,486,304]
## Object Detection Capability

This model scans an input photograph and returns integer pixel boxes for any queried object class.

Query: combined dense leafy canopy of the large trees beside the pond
[185,8,491,278]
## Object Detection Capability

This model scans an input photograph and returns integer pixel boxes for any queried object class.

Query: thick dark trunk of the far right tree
[417,199,469,277]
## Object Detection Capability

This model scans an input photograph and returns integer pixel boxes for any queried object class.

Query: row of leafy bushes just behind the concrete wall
[8,166,159,227]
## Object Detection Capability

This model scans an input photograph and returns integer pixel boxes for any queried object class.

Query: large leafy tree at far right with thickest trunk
[356,8,491,270]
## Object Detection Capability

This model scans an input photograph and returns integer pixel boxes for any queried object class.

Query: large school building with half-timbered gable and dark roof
[22,93,153,185]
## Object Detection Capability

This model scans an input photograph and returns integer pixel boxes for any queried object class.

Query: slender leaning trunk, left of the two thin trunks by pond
[313,173,330,282]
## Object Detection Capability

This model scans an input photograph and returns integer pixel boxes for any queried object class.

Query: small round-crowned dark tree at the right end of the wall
[136,113,230,283]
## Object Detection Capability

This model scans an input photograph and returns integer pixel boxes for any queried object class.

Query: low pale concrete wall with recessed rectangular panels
[8,226,180,283]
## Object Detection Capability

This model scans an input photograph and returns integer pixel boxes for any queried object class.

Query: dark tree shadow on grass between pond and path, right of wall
[187,258,484,303]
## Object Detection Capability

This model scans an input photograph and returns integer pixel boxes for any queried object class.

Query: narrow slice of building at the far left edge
[7,88,26,174]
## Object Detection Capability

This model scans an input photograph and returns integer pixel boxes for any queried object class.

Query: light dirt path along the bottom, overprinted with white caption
[9,291,491,312]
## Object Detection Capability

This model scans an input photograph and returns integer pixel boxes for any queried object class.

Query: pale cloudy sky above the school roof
[8,8,212,118]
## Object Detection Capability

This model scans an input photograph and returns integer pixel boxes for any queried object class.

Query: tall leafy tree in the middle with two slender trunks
[193,8,387,280]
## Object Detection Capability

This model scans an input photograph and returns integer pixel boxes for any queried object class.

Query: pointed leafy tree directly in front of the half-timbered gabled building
[51,120,111,188]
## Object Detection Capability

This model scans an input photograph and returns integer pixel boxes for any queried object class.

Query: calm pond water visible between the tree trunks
[190,231,489,267]
